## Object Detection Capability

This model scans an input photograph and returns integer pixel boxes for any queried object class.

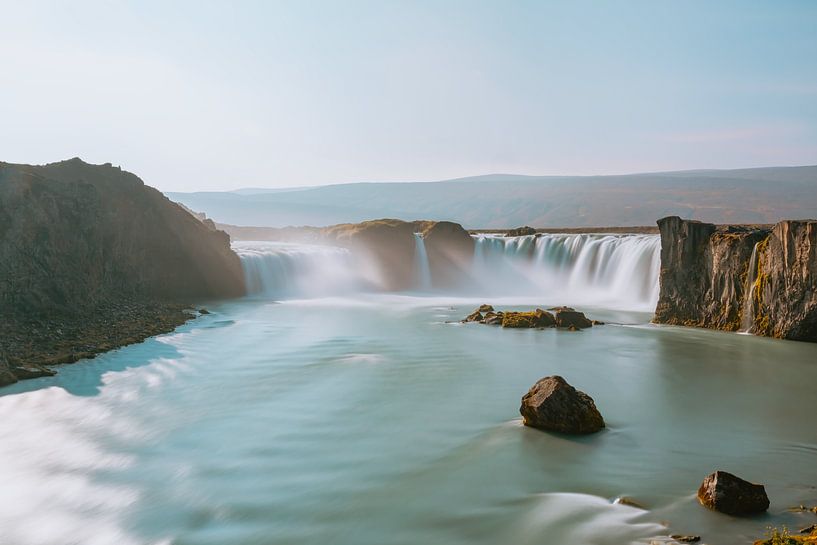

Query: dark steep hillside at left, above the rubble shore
[0,159,244,315]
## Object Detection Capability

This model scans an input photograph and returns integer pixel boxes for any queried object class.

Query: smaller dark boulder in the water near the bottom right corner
[698,471,769,515]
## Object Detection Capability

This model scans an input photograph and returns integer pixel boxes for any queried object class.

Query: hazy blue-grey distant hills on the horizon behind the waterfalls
[167,166,817,229]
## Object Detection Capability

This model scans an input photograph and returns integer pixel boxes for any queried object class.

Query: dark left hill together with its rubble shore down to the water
[0,159,244,382]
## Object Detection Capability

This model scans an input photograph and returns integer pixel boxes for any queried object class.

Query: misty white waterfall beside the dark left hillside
[233,241,367,298]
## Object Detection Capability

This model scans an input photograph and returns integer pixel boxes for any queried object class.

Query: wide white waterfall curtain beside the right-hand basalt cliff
[474,234,661,311]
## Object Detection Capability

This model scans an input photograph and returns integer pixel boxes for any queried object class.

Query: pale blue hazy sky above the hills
[0,0,817,191]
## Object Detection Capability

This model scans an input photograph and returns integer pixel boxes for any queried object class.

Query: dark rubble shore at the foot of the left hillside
[0,302,197,386]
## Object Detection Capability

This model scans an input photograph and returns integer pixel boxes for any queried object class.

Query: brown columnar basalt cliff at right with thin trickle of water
[654,216,817,342]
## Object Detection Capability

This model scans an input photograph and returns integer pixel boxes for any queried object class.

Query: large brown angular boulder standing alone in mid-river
[519,376,604,434]
